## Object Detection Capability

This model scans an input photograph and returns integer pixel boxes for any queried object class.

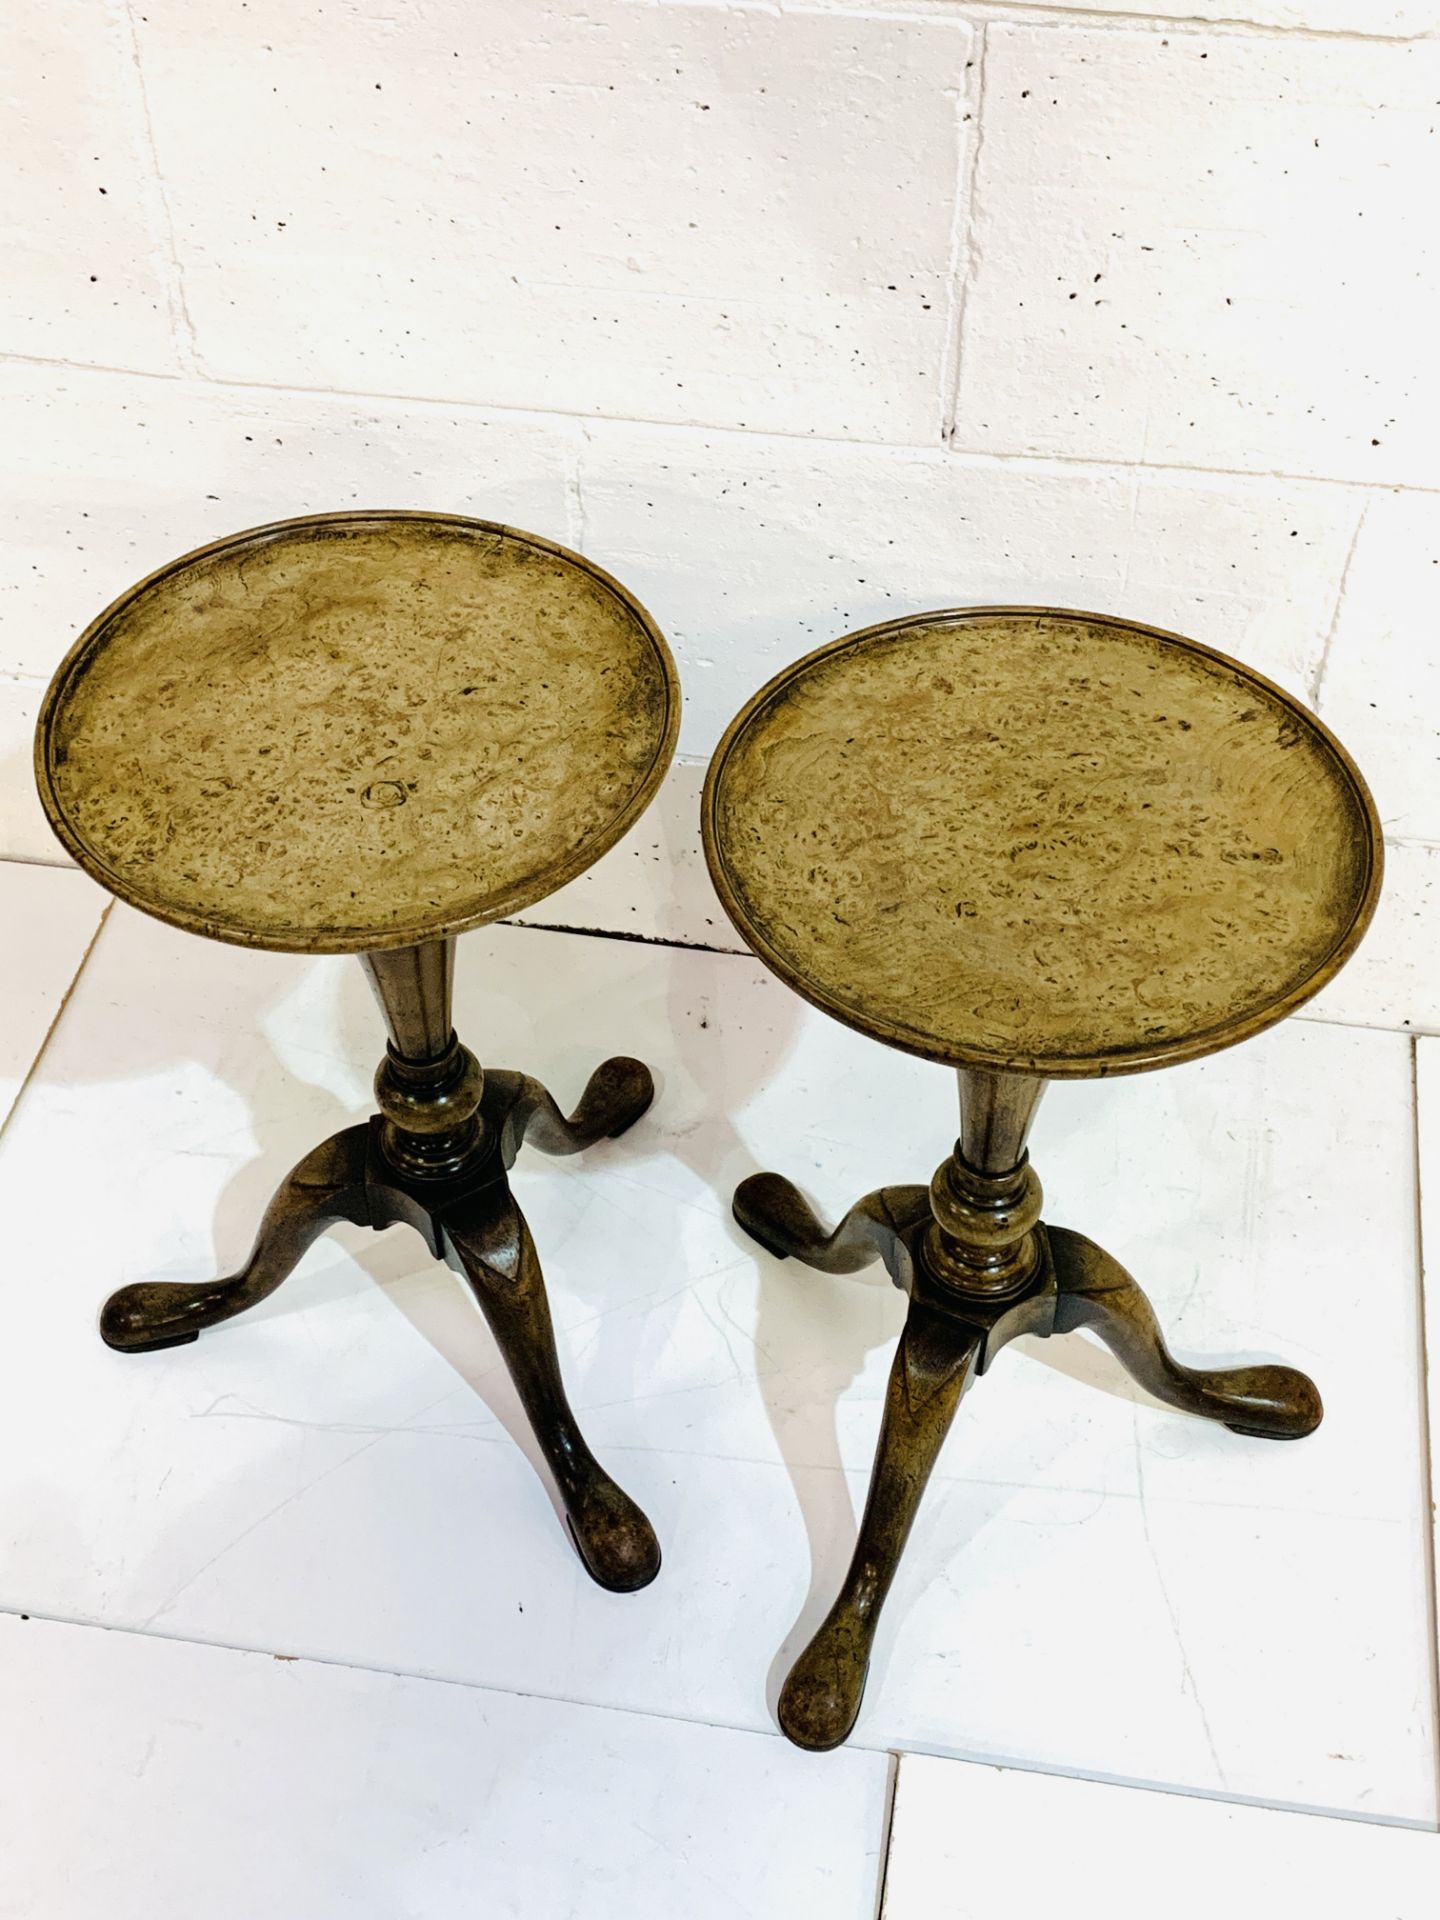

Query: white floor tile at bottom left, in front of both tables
[0,1619,889,1920]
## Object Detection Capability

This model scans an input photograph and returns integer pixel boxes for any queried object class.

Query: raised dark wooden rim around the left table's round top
[33,507,682,954]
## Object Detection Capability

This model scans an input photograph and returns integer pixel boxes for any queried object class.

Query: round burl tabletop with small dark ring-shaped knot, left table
[35,513,680,952]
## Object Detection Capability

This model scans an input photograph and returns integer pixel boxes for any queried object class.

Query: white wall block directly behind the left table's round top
[0,365,580,680]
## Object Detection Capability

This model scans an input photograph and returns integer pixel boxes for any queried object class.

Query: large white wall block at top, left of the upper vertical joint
[129,0,972,442]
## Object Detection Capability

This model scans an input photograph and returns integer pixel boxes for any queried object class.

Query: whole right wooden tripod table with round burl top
[703,607,1380,1747]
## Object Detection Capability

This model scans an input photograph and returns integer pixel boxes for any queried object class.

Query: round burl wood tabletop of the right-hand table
[703,607,1380,1079]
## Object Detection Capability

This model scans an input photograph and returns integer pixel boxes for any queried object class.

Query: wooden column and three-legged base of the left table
[100,941,660,1594]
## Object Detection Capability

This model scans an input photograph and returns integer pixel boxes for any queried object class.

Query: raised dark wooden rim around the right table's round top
[701,605,1384,1079]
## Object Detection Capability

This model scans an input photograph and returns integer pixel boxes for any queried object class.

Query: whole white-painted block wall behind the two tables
[0,0,1440,1025]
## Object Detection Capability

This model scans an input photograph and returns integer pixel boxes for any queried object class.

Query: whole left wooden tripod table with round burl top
[35,513,680,1592]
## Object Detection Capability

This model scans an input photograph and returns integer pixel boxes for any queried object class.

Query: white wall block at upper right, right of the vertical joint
[954,27,1440,484]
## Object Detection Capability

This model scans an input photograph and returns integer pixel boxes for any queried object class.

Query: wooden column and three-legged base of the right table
[733,1069,1323,1751]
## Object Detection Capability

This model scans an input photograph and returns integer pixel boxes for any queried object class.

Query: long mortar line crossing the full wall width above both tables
[0,349,1440,495]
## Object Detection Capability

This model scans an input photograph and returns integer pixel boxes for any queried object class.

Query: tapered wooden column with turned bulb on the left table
[359,939,488,1179]
